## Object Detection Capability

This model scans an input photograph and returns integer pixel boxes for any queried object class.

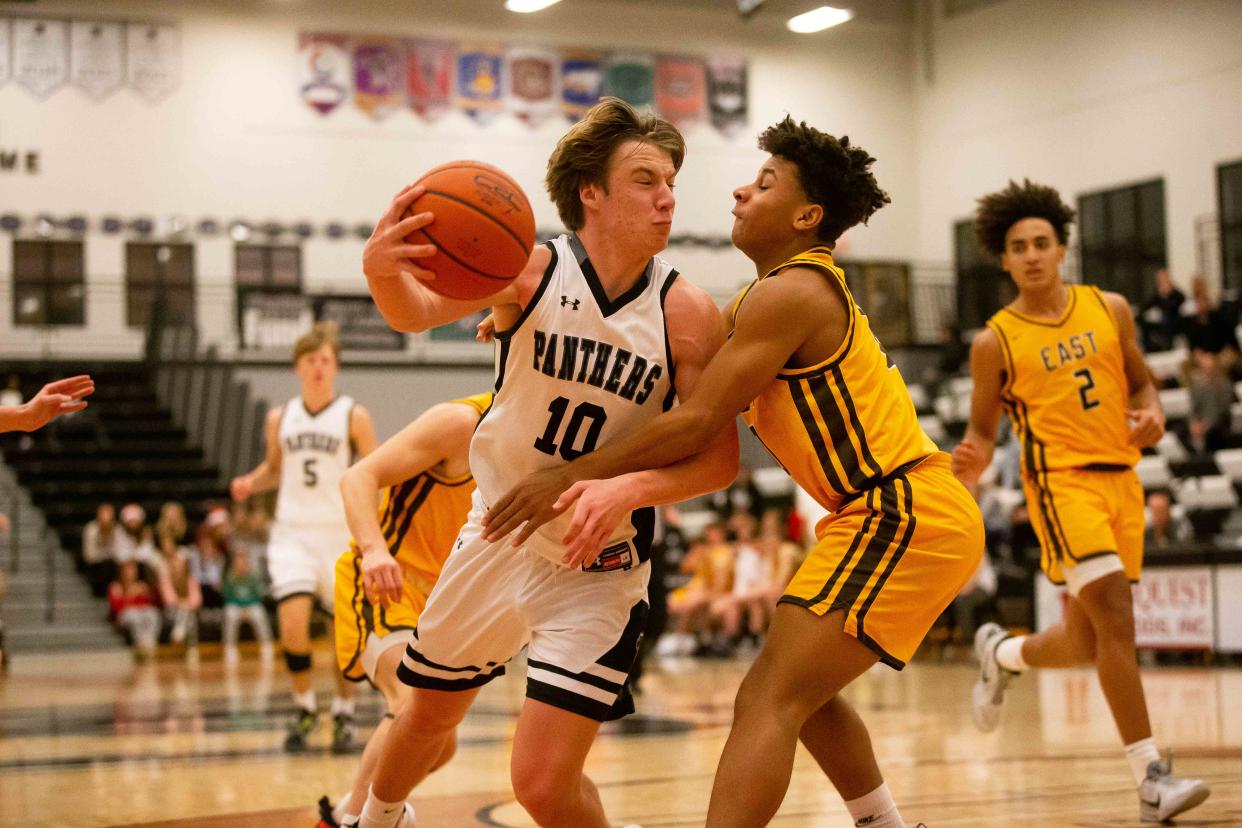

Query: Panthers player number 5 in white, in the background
[230,322,375,752]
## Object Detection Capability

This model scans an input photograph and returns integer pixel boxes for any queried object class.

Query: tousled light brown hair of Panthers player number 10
[544,97,686,231]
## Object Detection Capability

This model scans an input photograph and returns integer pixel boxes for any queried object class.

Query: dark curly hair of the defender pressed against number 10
[759,115,892,245]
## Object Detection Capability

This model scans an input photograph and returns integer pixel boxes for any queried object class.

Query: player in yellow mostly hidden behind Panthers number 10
[319,394,492,826]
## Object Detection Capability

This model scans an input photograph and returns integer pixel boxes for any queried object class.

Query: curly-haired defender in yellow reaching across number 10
[486,118,984,828]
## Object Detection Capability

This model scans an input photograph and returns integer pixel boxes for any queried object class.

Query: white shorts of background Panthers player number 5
[267,523,349,613]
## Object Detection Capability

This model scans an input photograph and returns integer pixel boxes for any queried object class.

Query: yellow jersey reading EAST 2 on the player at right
[987,284,1139,475]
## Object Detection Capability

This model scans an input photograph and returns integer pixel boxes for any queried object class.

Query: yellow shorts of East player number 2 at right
[1022,469,1144,593]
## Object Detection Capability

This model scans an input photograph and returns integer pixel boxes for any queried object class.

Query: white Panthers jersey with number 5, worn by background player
[276,396,354,525]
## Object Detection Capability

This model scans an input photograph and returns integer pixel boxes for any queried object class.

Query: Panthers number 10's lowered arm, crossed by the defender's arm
[553,278,738,569]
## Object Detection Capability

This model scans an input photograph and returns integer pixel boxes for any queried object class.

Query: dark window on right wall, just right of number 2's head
[1078,179,1167,305]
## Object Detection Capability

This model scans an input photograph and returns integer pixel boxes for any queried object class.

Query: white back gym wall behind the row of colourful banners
[0,0,917,356]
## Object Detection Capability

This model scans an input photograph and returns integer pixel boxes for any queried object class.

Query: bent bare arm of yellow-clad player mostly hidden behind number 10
[340,402,478,606]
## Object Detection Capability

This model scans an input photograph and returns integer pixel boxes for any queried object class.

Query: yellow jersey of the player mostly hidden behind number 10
[350,392,492,588]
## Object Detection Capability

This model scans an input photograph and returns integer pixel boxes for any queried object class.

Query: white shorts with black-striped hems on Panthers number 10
[397,515,651,721]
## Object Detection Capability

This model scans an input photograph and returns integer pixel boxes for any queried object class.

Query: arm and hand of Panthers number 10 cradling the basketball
[363,185,551,333]
